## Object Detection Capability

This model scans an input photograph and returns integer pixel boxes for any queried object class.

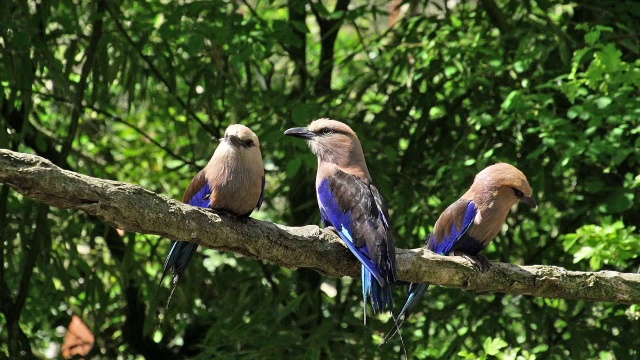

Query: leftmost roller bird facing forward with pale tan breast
[160,124,264,307]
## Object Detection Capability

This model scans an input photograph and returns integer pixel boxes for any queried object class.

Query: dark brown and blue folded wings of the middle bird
[317,171,396,286]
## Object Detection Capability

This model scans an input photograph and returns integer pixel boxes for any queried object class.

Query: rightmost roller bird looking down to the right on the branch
[388,163,537,340]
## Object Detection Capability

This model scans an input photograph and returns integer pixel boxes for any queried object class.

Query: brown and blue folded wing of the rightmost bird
[427,199,478,255]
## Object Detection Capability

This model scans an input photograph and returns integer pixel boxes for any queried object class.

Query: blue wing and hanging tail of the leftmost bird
[160,170,211,307]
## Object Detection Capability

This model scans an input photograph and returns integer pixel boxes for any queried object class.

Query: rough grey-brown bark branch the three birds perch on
[0,149,640,304]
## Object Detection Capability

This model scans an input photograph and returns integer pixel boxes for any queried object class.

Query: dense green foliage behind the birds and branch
[0,0,640,359]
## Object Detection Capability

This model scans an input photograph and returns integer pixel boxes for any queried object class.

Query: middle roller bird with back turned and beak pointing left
[284,119,396,321]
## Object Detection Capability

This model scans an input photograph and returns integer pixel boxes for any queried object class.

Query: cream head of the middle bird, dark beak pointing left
[284,119,369,178]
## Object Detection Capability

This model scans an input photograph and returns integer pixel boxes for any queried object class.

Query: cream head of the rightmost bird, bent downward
[467,163,537,208]
